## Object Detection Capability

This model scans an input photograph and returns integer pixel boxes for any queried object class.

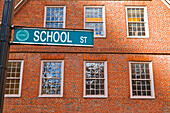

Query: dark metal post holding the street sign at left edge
[0,0,14,113]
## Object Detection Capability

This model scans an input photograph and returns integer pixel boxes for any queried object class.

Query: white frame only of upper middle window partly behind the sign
[84,6,106,38]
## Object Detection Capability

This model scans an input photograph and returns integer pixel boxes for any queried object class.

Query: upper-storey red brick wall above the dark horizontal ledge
[11,0,170,53]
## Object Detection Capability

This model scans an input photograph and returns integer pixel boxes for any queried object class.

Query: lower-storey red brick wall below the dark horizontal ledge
[4,53,170,113]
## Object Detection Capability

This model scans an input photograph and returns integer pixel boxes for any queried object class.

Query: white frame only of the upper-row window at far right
[125,6,149,38]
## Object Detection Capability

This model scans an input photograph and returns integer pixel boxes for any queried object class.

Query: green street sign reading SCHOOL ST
[13,28,94,46]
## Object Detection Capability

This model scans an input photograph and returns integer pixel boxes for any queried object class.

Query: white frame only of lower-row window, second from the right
[83,61,108,98]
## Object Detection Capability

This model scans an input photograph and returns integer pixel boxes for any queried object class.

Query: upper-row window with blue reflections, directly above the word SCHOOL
[44,6,66,28]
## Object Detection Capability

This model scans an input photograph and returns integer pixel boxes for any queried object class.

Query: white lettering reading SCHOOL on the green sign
[33,31,72,43]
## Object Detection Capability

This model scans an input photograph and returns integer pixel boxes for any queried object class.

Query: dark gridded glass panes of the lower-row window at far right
[130,63,151,96]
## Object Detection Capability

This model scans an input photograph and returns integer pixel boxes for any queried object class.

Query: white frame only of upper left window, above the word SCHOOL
[44,6,66,28]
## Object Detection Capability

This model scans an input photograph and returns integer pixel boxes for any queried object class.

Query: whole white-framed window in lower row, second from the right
[83,61,108,98]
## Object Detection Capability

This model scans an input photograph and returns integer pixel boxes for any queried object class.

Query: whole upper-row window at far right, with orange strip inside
[126,6,149,38]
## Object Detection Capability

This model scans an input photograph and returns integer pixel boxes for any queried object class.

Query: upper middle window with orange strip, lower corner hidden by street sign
[84,6,106,37]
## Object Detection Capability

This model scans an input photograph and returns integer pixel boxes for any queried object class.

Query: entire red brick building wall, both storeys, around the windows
[1,0,170,113]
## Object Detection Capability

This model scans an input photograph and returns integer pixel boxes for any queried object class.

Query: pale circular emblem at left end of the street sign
[16,30,29,41]
